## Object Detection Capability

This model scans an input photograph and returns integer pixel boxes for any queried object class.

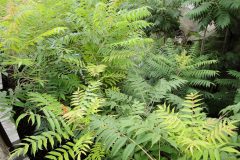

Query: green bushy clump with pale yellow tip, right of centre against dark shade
[125,41,218,106]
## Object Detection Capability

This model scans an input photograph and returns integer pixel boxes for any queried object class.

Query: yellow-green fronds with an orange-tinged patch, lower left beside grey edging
[10,82,104,160]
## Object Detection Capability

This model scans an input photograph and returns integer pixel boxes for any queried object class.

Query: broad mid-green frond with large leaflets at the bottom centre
[91,117,152,160]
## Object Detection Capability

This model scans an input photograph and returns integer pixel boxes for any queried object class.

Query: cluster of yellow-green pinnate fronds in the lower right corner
[156,93,240,160]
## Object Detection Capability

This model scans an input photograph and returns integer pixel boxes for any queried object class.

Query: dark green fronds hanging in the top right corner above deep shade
[183,0,240,29]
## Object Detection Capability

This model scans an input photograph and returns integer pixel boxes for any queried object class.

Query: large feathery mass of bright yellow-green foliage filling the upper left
[0,0,152,91]
